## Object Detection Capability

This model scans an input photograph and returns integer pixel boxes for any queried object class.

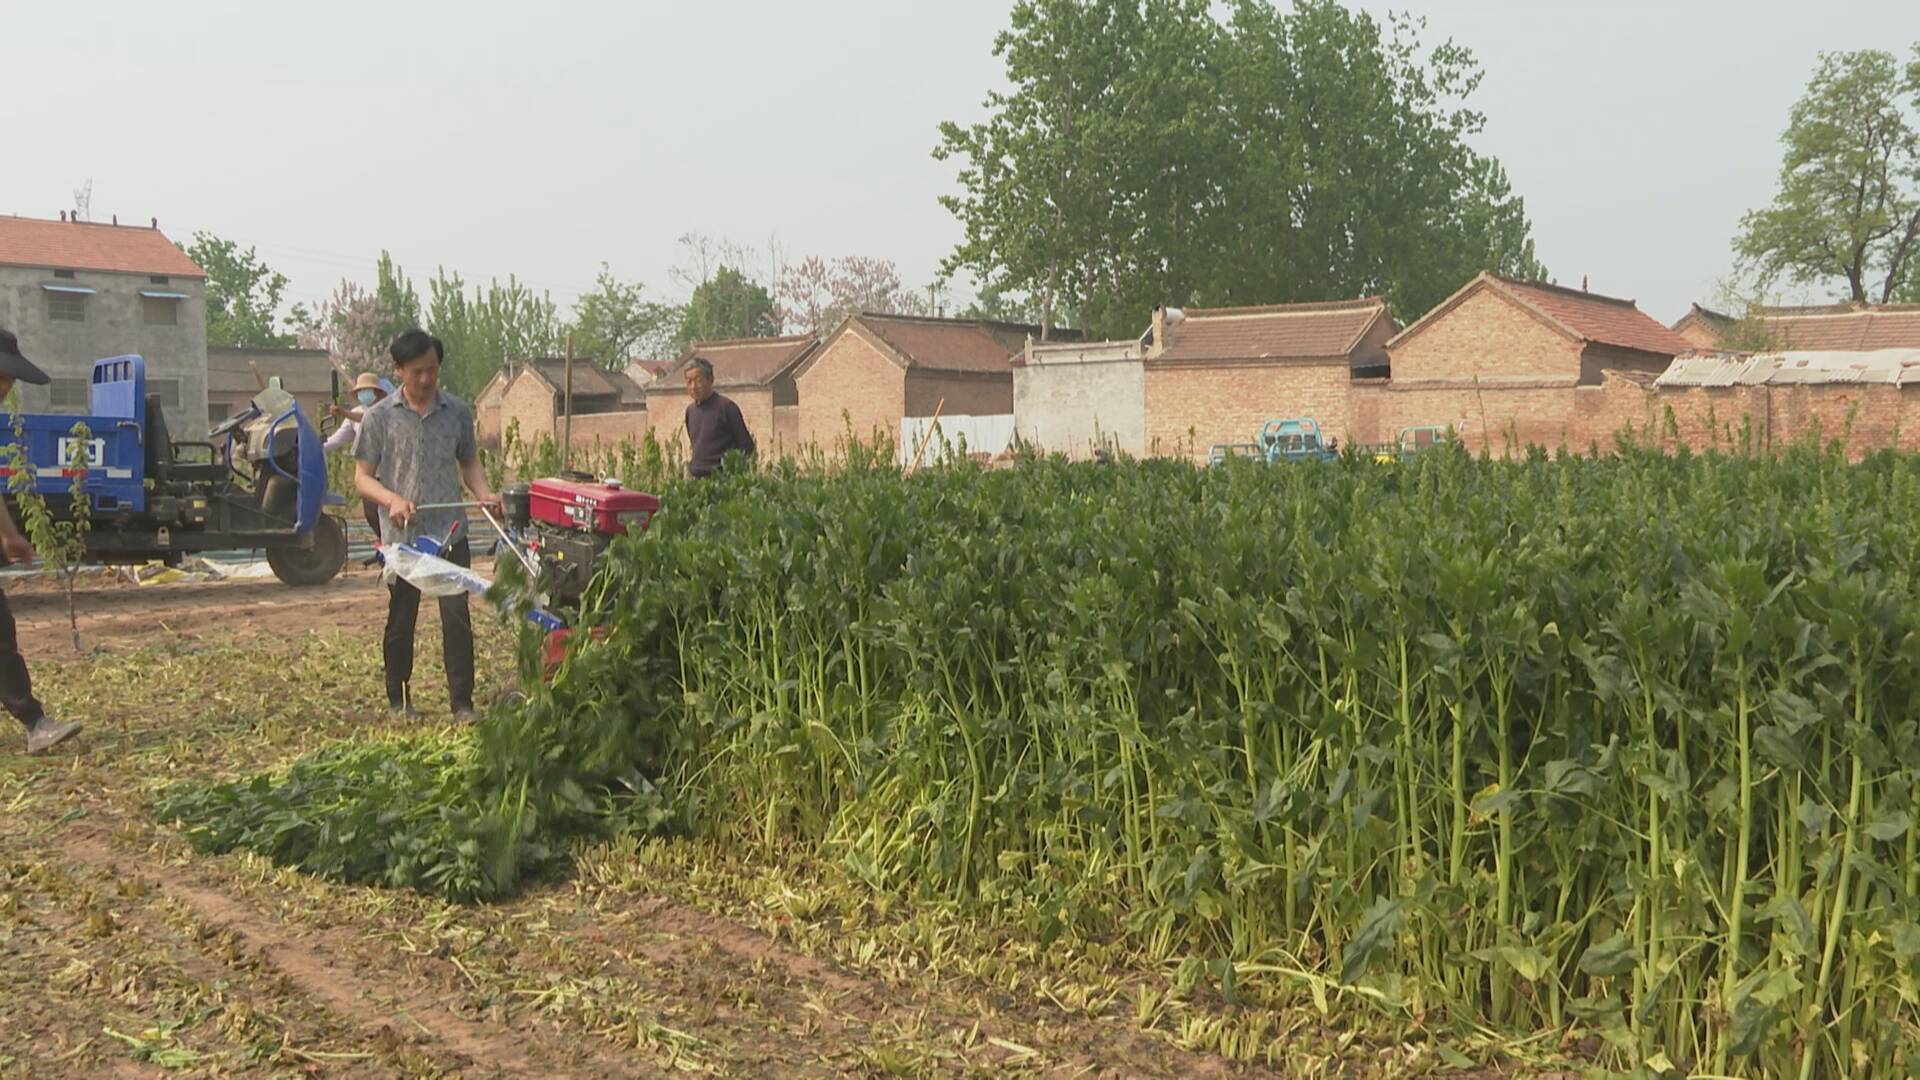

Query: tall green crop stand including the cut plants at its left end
[165,452,1920,1074]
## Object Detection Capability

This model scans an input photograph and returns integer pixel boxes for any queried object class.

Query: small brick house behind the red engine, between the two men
[474,357,647,444]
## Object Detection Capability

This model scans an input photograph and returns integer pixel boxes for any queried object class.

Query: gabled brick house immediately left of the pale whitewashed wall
[793,313,1079,450]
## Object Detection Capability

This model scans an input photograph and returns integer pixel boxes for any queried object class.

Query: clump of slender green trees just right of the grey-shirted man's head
[426,269,564,398]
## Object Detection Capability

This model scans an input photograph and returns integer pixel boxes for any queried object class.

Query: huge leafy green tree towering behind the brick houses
[935,0,1544,334]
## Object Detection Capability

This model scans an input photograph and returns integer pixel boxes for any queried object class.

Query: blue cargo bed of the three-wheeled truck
[0,356,146,513]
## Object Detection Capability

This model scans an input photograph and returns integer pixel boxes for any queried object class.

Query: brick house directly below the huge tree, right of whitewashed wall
[1140,296,1398,461]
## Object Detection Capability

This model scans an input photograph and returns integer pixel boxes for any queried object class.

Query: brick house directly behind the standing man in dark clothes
[645,334,820,457]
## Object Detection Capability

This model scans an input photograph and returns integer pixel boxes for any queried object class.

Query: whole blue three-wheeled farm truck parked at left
[0,356,348,586]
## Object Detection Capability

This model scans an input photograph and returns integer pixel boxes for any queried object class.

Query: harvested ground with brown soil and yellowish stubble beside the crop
[0,569,1528,1076]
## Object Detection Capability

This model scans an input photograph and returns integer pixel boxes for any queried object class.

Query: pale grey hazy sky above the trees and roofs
[0,0,1920,330]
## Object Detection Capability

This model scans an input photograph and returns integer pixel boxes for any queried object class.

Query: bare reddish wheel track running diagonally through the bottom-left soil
[61,832,655,1076]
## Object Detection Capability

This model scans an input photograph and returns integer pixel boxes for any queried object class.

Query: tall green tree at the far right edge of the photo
[1734,44,1920,304]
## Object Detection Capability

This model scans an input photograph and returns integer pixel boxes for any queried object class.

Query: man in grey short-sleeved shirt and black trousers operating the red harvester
[353,329,495,721]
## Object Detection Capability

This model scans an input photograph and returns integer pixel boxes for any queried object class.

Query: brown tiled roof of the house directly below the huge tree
[1150,296,1386,363]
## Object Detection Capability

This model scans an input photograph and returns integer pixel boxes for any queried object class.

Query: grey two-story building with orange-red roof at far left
[0,217,207,438]
